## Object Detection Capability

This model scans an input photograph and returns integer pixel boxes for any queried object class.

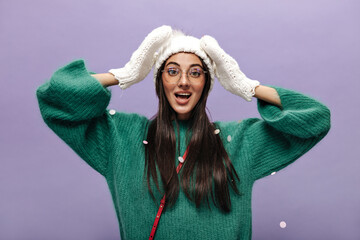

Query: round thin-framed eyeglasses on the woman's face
[161,66,207,84]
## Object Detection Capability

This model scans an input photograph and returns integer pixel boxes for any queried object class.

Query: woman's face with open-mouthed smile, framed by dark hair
[162,53,205,120]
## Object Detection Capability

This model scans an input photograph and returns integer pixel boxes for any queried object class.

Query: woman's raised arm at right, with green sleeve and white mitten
[201,36,330,180]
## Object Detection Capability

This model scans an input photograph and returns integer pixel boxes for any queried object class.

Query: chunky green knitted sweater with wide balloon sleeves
[37,60,330,240]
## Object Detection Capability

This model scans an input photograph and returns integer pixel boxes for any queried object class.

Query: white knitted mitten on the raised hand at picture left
[109,25,172,89]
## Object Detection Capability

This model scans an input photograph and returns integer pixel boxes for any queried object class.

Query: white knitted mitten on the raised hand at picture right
[200,36,260,102]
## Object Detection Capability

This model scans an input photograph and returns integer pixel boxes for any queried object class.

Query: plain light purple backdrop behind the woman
[0,0,360,240]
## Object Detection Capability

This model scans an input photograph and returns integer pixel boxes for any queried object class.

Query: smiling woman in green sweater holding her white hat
[37,26,330,239]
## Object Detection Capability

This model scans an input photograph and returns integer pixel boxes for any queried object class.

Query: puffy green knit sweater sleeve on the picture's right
[245,87,330,180]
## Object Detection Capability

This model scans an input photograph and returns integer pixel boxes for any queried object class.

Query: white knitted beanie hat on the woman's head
[154,30,215,91]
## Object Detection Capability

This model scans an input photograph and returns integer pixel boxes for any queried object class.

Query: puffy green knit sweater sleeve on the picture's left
[37,60,111,175]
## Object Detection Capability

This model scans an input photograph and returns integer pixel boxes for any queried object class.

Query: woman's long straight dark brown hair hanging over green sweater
[145,54,240,212]
